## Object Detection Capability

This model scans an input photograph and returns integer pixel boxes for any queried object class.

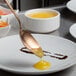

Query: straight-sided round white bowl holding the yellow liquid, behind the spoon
[24,8,60,33]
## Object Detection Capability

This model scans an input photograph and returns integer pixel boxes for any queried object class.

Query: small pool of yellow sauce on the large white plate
[33,59,51,70]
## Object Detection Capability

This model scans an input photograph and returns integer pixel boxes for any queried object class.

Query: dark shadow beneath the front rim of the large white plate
[0,66,74,76]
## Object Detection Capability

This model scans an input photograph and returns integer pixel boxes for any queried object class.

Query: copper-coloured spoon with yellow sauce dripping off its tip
[4,0,44,58]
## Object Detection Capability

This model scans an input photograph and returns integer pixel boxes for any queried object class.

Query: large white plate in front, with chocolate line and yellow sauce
[0,34,76,75]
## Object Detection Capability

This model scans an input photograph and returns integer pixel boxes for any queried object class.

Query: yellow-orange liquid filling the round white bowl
[28,11,57,18]
